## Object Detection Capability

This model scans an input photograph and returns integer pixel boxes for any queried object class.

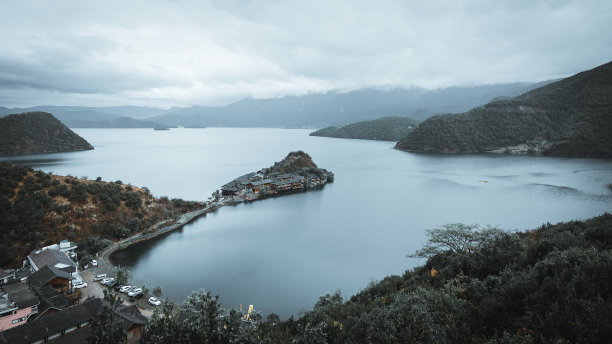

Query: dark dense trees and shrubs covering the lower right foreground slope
[130,214,612,344]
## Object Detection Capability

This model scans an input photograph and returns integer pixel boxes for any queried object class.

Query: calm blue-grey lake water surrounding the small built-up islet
[2,128,612,317]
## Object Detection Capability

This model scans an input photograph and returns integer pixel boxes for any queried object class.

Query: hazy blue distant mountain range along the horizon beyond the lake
[0,82,548,128]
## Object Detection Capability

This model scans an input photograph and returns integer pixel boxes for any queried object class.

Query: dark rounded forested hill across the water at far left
[0,112,93,155]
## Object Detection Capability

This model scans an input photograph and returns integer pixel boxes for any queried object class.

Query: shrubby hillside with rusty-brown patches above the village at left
[0,162,203,268]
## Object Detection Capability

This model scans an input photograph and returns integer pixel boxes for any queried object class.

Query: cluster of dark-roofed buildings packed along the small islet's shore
[221,171,328,197]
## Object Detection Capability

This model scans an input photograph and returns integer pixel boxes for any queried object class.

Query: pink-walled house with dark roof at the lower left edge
[0,282,40,331]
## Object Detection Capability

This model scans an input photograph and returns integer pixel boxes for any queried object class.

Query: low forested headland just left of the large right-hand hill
[310,116,419,141]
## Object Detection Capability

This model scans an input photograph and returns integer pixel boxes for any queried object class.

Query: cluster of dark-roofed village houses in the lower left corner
[0,241,147,344]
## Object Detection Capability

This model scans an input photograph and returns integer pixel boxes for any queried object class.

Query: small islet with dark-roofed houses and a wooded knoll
[219,151,334,203]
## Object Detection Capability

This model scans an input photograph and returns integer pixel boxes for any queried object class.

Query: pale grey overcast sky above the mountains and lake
[0,0,612,107]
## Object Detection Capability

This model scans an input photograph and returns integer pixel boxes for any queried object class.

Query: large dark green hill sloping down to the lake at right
[395,62,612,158]
